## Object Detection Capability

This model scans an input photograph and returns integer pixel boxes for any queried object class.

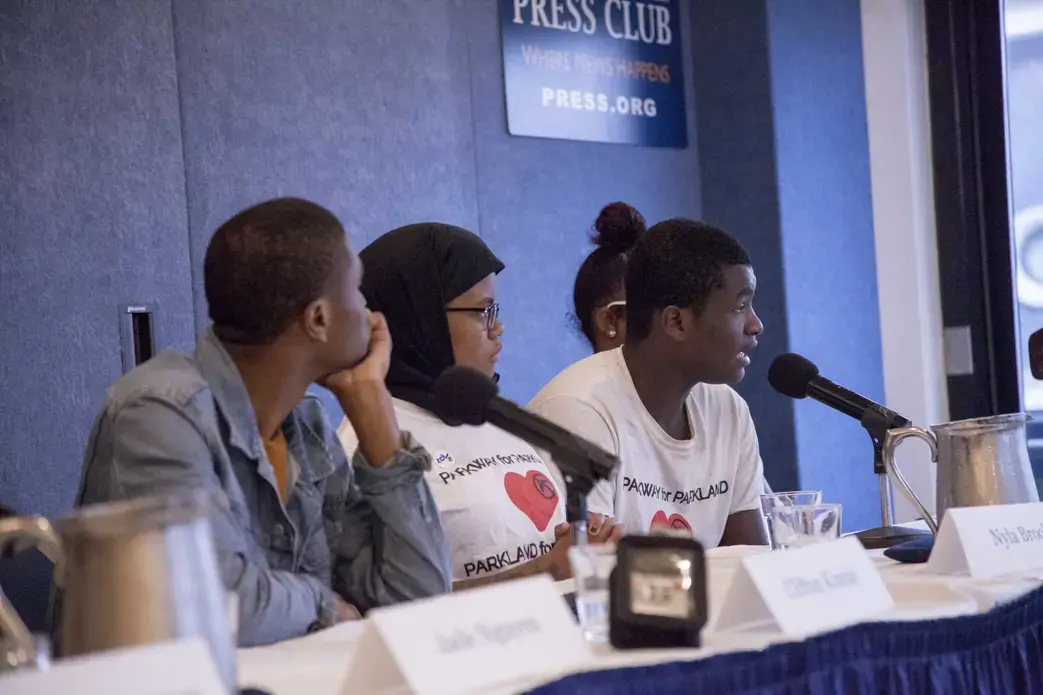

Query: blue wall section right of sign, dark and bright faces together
[693,0,883,529]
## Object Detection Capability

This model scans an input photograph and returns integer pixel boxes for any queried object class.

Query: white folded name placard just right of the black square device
[714,537,895,637]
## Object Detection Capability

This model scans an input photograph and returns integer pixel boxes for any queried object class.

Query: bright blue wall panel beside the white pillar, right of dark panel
[768,0,884,529]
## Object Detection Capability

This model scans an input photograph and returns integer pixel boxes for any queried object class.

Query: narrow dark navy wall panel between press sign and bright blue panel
[692,0,798,489]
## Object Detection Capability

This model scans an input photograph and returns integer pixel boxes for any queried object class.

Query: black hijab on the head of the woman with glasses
[359,222,504,409]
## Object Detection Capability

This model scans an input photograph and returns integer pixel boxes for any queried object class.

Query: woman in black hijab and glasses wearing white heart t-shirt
[339,222,618,589]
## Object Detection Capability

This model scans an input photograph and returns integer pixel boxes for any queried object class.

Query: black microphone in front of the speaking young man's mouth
[768,353,912,430]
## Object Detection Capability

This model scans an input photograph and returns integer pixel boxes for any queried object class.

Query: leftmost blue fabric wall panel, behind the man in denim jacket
[0,0,193,513]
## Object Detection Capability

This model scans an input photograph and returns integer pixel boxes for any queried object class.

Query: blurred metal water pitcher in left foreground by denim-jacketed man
[0,493,236,692]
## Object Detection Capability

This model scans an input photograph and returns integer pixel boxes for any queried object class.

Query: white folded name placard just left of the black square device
[342,575,588,695]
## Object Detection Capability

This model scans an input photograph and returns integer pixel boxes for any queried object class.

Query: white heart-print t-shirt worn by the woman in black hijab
[337,399,565,581]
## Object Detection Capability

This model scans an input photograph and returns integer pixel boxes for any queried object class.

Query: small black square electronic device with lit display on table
[609,535,707,649]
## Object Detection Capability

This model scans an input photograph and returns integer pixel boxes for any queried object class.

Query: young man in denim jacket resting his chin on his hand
[77,198,451,646]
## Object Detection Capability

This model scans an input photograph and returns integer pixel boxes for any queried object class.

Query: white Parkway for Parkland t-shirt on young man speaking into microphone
[529,350,763,548]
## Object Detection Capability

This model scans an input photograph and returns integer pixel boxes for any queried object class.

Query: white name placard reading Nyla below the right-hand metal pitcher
[927,502,1043,579]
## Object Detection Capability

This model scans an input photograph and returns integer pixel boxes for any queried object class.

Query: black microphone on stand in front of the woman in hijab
[432,366,620,522]
